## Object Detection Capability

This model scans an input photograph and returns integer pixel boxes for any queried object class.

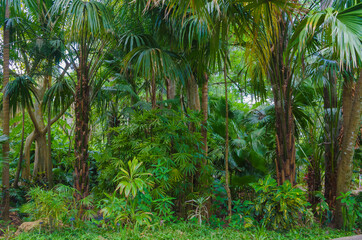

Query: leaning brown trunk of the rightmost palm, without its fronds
[336,72,362,228]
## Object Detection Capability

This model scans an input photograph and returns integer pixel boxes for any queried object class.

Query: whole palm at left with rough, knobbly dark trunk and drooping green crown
[52,0,112,200]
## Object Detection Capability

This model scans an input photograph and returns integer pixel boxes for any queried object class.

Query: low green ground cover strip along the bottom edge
[12,222,354,240]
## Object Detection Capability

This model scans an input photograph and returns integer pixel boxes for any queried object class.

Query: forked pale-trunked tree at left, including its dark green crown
[4,0,68,182]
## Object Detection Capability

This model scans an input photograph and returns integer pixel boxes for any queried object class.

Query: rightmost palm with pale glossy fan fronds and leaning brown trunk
[299,1,362,227]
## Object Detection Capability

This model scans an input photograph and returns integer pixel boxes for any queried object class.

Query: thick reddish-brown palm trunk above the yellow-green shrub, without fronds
[268,13,295,185]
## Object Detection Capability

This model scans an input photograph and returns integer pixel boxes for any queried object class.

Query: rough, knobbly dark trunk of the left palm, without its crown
[74,63,90,200]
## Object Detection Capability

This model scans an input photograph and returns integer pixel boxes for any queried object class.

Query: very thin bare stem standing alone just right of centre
[224,46,232,223]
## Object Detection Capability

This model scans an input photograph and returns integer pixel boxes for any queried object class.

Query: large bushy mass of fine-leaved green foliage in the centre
[98,109,208,199]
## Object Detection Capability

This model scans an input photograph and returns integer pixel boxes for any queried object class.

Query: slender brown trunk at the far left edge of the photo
[1,0,10,221]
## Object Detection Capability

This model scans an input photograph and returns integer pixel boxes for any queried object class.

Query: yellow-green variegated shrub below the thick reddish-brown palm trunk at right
[250,175,308,229]
